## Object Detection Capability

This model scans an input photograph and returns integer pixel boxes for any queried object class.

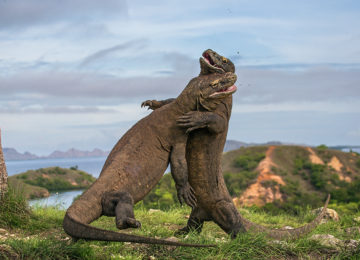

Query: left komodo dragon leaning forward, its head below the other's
[63,67,236,247]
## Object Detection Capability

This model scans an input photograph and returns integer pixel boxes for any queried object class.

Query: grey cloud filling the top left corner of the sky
[0,0,127,29]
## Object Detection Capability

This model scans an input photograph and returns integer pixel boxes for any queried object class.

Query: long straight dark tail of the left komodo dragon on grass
[63,214,215,247]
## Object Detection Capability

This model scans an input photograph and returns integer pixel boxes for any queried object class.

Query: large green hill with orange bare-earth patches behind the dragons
[143,145,360,211]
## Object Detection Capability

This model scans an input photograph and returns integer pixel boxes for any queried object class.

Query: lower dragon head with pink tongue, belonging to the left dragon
[177,72,237,111]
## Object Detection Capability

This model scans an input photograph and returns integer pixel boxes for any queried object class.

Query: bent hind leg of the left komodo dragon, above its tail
[101,191,141,229]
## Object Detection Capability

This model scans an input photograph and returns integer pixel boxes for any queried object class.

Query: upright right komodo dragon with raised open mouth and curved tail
[143,50,330,239]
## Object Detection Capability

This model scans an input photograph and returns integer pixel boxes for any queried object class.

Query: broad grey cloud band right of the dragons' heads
[237,67,360,104]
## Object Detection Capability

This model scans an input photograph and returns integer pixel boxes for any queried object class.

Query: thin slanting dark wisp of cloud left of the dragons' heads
[79,39,146,67]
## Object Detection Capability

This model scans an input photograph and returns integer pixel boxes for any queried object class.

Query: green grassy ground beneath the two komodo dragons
[0,200,360,259]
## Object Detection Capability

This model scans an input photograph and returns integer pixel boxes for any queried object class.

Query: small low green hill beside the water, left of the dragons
[8,167,95,199]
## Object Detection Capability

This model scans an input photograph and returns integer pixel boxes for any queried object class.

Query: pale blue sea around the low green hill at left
[6,156,106,209]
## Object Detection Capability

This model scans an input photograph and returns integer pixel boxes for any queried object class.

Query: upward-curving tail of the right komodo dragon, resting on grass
[240,194,330,239]
